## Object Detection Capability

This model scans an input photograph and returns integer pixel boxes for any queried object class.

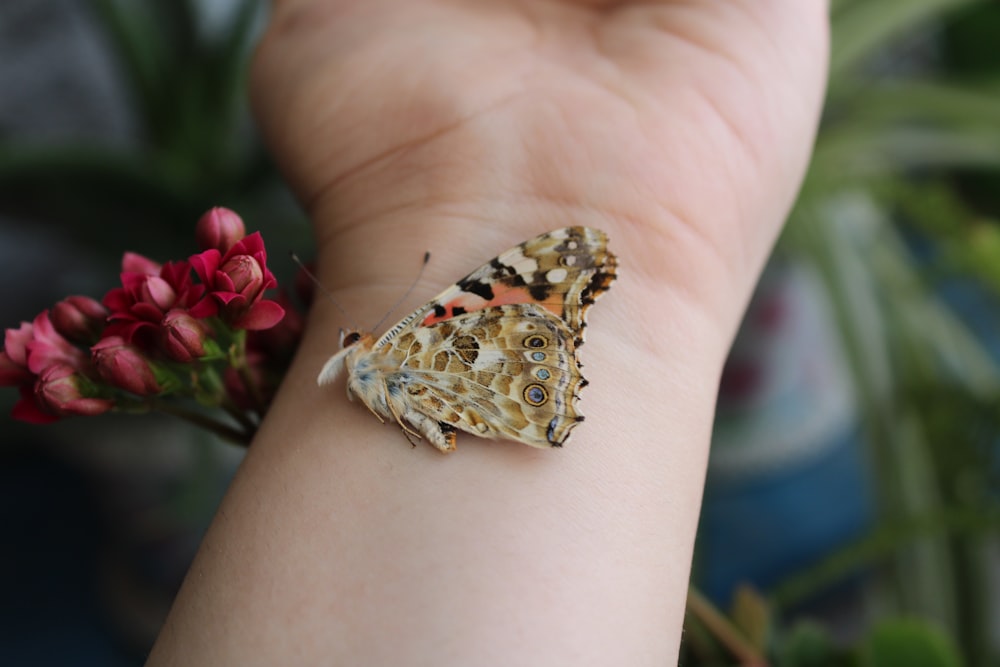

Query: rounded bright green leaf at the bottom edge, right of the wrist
[860,618,964,667]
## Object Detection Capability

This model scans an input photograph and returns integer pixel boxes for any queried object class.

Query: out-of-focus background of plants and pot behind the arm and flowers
[0,0,1000,666]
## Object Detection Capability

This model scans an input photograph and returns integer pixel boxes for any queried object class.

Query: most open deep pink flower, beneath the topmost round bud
[191,232,285,331]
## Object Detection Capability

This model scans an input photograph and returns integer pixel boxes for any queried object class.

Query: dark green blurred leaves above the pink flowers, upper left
[0,0,307,259]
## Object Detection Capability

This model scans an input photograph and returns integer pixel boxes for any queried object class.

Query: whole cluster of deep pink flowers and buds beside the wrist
[0,208,303,442]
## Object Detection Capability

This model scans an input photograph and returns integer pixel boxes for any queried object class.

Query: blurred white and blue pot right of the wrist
[695,258,874,605]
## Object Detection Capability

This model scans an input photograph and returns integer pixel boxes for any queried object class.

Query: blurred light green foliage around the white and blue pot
[685,0,1000,667]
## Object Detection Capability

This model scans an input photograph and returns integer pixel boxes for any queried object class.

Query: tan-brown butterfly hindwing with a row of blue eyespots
[386,304,587,447]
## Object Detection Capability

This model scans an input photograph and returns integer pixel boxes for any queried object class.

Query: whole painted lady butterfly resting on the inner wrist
[318,227,617,453]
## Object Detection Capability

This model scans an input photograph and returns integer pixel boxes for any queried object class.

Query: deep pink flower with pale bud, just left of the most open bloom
[103,253,205,350]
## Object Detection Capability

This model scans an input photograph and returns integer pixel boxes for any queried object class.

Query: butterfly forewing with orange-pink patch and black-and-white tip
[374,227,618,349]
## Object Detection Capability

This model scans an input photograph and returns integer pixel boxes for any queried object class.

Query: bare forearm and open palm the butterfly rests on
[149,0,827,666]
